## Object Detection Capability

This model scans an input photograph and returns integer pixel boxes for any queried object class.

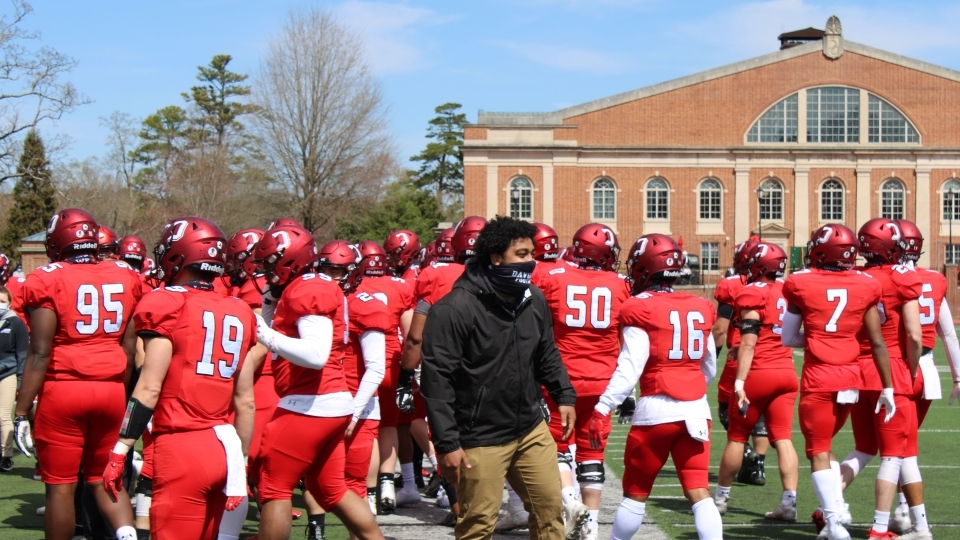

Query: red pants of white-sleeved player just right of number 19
[258,408,352,512]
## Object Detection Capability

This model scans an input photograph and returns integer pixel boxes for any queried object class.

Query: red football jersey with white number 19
[133,286,257,434]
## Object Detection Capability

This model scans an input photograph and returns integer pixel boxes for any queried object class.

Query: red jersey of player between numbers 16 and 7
[734,281,794,371]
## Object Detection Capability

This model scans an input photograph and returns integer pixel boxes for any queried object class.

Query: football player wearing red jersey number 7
[781,223,896,540]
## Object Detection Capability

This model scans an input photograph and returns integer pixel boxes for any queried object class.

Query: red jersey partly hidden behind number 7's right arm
[857,264,923,394]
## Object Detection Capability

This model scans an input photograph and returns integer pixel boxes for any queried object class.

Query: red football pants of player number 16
[624,421,711,497]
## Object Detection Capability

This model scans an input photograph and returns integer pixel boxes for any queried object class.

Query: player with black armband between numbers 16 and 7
[713,246,799,522]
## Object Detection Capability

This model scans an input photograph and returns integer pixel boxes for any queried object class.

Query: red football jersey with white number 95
[23,260,142,381]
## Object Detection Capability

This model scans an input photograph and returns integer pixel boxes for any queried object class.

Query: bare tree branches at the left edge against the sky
[0,0,89,182]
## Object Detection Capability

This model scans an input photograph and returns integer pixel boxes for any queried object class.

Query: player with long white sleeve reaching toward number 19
[253,231,383,540]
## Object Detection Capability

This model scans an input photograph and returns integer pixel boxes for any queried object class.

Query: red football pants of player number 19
[150,429,227,540]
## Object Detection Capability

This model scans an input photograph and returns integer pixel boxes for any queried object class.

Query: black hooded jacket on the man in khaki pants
[420,258,577,454]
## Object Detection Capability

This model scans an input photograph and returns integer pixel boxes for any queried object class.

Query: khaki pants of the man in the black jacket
[455,422,563,540]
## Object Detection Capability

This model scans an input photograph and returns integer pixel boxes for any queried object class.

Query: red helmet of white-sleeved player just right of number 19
[253,226,317,287]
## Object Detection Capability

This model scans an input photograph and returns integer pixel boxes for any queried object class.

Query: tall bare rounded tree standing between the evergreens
[253,8,395,235]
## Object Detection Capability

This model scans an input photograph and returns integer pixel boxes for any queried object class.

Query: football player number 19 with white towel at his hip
[104,218,257,540]
